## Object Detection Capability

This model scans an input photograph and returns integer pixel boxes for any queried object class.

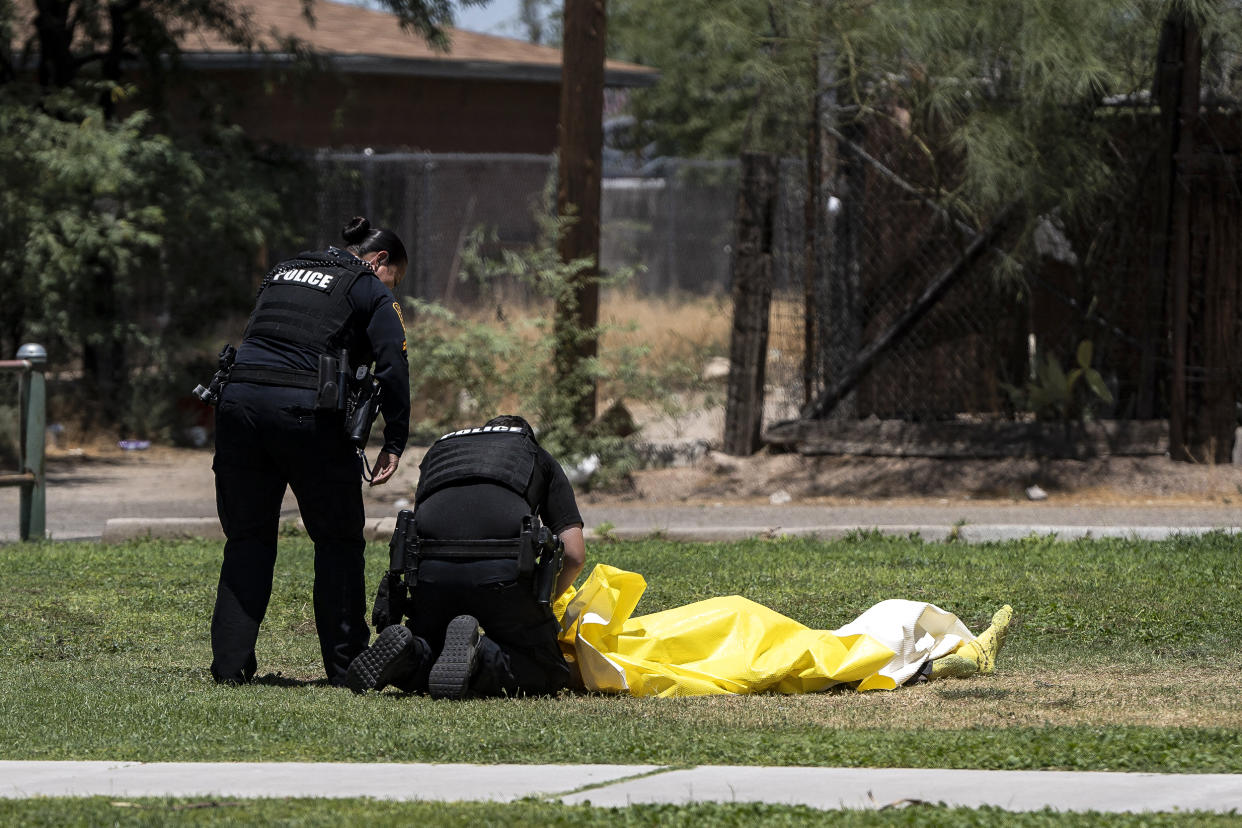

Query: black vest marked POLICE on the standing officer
[245,252,373,354]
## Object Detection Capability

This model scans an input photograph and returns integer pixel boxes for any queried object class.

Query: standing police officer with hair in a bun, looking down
[211,217,410,684]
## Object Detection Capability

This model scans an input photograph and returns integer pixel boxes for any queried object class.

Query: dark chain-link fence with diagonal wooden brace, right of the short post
[768,117,1222,431]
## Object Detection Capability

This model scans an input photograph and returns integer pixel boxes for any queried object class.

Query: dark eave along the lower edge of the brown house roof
[180,52,660,88]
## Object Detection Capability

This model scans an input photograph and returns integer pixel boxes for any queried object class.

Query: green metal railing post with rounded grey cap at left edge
[0,343,47,540]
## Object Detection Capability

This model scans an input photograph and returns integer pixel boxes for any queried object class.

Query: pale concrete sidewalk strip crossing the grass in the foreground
[0,761,1242,813]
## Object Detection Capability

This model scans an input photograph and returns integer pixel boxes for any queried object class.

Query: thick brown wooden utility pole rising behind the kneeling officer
[555,0,607,427]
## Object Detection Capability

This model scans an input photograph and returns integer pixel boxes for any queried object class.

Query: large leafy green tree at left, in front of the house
[0,0,473,436]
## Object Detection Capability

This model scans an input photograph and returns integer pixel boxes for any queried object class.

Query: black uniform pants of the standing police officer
[211,382,370,683]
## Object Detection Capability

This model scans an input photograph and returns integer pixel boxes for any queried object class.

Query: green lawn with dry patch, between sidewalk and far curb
[0,535,1242,774]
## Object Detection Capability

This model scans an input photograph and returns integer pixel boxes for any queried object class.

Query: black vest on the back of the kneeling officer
[416,426,539,505]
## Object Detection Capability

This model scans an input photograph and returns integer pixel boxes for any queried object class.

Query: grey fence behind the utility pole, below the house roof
[307,153,737,304]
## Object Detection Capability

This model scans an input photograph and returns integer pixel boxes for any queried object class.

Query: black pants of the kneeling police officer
[407,561,569,696]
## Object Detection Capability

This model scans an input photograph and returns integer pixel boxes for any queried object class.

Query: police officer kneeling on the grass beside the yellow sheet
[347,415,585,699]
